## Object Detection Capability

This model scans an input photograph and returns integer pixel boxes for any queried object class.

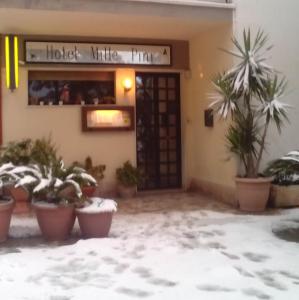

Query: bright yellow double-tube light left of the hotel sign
[5,35,19,91]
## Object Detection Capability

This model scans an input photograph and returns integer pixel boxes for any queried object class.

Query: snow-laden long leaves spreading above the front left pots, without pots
[0,160,96,204]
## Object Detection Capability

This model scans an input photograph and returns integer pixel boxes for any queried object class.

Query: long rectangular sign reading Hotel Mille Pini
[25,41,171,66]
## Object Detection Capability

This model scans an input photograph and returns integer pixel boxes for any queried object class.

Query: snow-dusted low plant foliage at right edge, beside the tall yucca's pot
[264,151,299,185]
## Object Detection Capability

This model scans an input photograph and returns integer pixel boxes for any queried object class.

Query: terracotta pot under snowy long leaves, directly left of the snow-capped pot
[33,203,76,241]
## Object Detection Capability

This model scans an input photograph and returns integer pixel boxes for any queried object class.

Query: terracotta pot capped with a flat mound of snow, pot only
[76,210,113,239]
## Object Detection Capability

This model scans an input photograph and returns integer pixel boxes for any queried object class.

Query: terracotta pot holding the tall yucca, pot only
[236,177,273,212]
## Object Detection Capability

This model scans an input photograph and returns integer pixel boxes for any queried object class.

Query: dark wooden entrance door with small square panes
[136,73,182,190]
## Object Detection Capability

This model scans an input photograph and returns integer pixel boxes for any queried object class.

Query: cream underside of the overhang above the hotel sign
[0,8,232,39]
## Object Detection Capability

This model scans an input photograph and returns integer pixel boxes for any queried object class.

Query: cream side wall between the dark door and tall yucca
[185,24,236,187]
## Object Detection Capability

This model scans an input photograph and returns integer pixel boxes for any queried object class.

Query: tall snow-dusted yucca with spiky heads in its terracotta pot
[210,30,289,211]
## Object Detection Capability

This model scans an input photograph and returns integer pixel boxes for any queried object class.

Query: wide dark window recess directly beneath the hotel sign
[28,71,116,105]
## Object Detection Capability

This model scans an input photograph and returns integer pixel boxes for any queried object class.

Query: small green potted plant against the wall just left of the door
[116,161,141,198]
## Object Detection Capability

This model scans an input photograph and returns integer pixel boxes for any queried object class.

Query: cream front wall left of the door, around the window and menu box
[2,67,136,189]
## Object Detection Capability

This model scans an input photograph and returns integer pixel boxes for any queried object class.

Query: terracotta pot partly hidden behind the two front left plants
[7,186,31,214]
